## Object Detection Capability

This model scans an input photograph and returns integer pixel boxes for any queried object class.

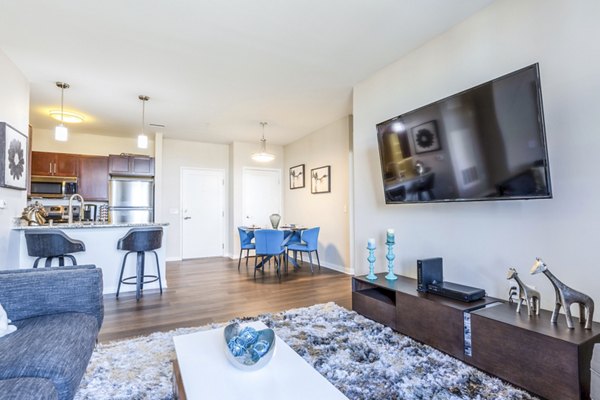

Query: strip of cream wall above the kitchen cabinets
[32,127,154,157]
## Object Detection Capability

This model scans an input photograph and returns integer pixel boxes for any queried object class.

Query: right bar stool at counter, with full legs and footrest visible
[117,227,163,300]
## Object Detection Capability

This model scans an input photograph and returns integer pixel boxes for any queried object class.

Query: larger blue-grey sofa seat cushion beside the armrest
[0,313,98,400]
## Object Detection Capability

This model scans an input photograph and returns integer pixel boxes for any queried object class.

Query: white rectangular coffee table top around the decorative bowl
[173,322,347,400]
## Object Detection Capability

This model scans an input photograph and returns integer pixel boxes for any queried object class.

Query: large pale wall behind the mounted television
[353,0,600,320]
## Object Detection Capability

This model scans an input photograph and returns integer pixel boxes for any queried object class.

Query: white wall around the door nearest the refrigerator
[162,138,230,260]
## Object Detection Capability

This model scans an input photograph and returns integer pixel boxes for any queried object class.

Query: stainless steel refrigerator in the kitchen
[108,177,154,224]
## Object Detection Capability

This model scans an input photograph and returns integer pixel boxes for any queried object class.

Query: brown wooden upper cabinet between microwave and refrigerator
[78,156,108,201]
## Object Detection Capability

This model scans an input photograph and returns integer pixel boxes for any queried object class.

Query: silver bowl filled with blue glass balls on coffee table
[224,322,275,371]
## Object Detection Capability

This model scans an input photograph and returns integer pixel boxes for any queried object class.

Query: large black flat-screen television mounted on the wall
[377,64,552,204]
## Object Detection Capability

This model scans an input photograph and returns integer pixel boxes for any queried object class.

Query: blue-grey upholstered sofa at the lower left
[0,265,104,400]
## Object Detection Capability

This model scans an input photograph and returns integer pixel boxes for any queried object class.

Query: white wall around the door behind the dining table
[231,140,285,258]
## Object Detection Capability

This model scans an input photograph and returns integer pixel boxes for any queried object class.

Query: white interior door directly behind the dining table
[242,168,281,228]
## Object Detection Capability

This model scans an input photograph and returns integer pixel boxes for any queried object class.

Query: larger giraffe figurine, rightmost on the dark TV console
[531,258,594,329]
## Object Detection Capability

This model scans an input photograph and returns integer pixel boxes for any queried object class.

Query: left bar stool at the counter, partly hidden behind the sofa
[25,229,85,268]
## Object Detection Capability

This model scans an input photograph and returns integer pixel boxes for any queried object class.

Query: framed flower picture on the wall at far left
[0,122,27,190]
